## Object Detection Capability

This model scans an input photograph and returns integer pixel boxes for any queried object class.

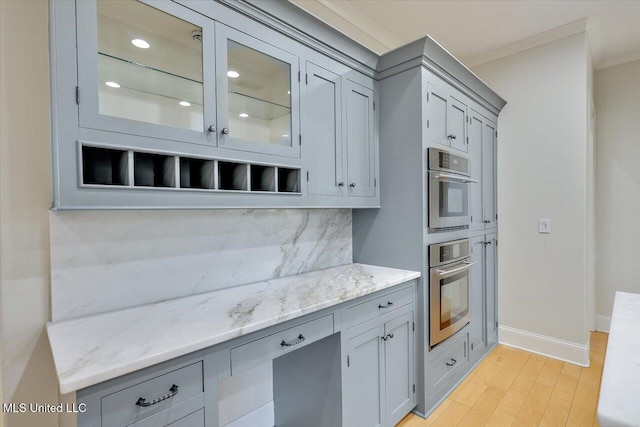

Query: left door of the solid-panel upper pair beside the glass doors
[302,62,345,196]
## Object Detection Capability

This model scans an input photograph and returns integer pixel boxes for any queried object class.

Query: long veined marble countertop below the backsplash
[47,264,420,394]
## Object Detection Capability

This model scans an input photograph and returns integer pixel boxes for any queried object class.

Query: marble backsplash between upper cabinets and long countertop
[50,209,352,321]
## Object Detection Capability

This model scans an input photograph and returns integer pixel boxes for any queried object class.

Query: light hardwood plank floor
[396,332,608,427]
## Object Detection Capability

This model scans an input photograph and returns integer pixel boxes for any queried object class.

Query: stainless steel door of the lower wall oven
[429,260,477,347]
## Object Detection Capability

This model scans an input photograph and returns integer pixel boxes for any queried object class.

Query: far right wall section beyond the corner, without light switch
[595,61,640,330]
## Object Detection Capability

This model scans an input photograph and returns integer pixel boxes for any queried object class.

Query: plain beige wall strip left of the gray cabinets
[0,0,58,427]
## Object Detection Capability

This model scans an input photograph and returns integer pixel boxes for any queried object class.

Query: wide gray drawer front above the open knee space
[231,314,333,375]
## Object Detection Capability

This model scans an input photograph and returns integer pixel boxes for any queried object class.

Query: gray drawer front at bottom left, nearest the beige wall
[102,362,204,427]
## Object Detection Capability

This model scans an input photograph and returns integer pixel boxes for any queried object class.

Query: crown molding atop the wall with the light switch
[464,18,587,68]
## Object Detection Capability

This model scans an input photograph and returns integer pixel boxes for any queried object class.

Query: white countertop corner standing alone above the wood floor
[598,292,640,427]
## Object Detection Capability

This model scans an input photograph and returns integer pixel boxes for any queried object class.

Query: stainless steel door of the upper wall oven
[429,171,477,228]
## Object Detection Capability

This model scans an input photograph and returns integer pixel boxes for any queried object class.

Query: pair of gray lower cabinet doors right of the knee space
[342,305,416,427]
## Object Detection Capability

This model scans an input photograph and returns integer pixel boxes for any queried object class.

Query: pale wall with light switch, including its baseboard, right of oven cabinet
[473,33,593,364]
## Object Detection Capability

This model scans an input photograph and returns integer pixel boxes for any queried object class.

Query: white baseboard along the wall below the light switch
[498,326,589,366]
